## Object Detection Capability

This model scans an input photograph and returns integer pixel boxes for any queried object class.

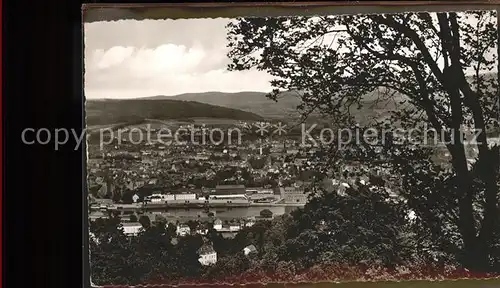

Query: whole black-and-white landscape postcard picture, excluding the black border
[83,6,500,287]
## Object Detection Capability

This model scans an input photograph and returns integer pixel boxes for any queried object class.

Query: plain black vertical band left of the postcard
[0,0,83,287]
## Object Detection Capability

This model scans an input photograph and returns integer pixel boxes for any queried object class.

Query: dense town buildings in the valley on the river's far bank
[87,123,315,209]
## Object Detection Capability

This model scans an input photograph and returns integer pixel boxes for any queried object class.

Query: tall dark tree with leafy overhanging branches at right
[228,11,499,270]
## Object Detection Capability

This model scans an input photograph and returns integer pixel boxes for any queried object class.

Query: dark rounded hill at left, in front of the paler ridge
[85,98,263,125]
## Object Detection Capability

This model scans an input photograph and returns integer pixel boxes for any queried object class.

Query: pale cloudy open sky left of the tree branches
[84,18,272,99]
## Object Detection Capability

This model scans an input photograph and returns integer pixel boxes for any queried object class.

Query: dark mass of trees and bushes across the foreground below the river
[90,181,500,285]
